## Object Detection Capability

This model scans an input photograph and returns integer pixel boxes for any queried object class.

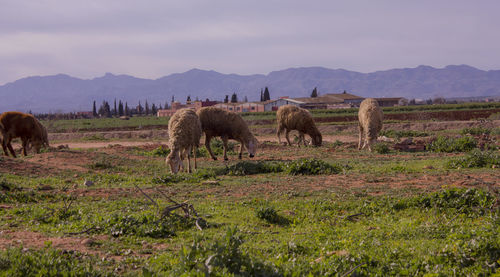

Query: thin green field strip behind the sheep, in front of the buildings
[42,102,500,132]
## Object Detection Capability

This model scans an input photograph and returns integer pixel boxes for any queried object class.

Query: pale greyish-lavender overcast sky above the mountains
[0,0,500,85]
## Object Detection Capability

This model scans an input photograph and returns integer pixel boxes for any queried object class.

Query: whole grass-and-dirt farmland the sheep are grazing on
[0,105,500,276]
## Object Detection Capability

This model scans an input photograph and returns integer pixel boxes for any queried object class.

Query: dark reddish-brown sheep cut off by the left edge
[0,112,48,157]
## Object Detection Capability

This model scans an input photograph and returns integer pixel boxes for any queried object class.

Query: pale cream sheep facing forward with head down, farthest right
[358,98,384,152]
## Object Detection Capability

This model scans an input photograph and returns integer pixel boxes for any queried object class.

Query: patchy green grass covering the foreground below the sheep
[0,139,500,276]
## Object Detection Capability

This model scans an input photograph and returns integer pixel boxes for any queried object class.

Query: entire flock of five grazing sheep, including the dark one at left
[0,98,383,170]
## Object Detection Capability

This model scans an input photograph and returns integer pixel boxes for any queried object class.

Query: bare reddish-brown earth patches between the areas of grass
[0,120,500,259]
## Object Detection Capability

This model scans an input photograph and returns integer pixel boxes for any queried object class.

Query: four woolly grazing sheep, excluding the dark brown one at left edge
[166,98,383,173]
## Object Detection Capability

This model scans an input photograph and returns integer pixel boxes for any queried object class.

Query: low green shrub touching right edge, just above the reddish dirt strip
[447,149,500,168]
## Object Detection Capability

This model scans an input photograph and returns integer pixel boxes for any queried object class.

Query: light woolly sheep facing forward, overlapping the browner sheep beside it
[166,109,202,174]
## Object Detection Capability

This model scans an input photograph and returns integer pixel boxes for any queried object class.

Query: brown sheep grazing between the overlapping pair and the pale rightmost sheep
[276,105,323,147]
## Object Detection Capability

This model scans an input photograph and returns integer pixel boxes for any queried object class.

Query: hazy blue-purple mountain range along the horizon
[0,65,500,113]
